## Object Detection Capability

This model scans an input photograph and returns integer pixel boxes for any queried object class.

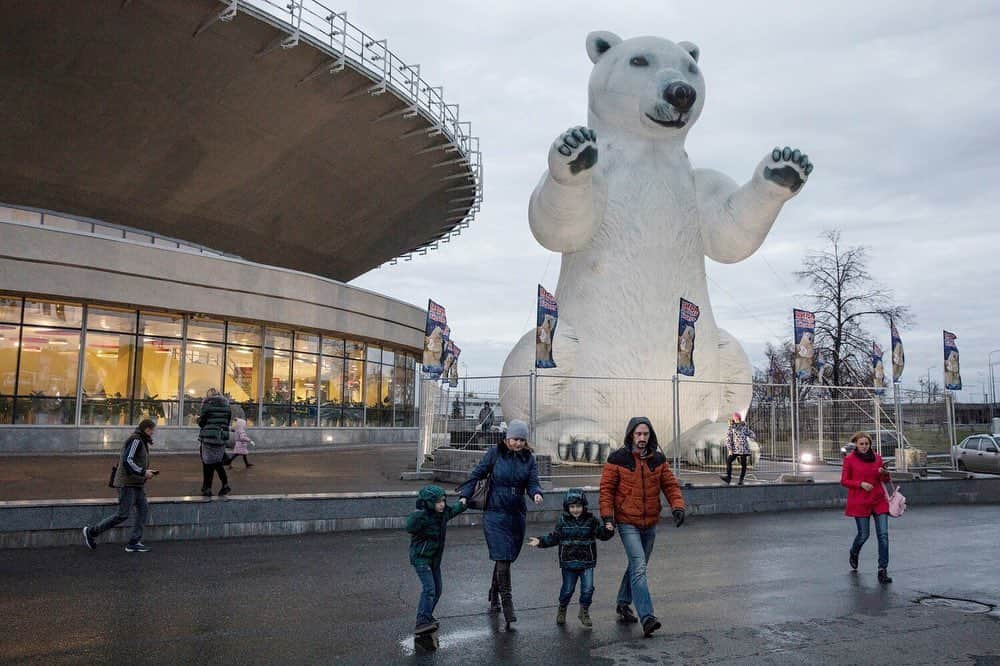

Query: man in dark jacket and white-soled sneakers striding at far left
[83,419,159,553]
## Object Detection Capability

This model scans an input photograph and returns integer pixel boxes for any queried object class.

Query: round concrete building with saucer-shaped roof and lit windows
[0,0,482,453]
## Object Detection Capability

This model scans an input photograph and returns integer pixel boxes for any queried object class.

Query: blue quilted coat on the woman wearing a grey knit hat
[459,443,542,561]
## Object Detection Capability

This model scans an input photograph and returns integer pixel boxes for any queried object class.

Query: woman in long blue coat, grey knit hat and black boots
[460,420,542,629]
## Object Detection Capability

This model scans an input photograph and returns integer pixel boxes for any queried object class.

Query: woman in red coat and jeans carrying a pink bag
[840,432,892,584]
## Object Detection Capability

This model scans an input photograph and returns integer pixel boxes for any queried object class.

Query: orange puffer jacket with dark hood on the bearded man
[600,419,685,528]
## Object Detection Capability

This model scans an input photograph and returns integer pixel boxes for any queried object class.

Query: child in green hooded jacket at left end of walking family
[406,486,465,636]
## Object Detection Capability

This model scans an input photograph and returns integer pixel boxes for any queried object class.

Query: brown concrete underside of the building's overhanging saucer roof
[0,0,477,280]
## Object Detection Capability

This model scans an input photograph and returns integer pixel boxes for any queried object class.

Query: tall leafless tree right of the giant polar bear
[795,230,912,386]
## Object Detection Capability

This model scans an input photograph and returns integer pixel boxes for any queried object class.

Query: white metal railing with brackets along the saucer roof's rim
[195,0,483,264]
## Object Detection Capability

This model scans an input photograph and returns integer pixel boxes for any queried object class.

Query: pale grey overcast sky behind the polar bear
[338,0,1000,400]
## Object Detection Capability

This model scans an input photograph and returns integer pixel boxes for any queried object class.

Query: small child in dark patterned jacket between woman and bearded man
[528,488,615,627]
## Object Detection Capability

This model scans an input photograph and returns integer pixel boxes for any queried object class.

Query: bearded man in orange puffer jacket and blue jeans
[600,416,685,636]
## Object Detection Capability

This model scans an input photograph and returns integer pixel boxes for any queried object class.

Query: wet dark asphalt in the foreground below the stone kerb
[0,506,1000,665]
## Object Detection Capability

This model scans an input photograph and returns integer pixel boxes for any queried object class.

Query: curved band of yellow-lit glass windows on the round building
[0,294,416,427]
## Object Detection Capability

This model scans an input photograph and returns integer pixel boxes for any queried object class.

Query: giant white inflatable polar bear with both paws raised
[500,32,812,462]
